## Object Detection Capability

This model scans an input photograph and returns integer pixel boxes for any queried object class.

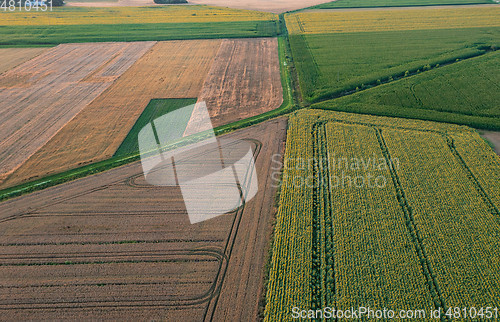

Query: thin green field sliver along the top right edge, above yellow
[312,0,494,9]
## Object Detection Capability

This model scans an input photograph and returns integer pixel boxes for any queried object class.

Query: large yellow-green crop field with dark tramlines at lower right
[266,110,500,321]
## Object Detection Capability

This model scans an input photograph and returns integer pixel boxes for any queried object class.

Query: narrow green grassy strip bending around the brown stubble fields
[0,37,293,201]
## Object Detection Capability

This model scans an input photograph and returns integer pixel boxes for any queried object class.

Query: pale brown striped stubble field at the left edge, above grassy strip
[0,42,154,187]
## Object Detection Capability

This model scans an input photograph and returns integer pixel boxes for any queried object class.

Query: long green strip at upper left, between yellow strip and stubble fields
[0,21,278,46]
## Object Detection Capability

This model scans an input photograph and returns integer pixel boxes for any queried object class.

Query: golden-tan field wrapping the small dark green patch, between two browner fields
[0,40,221,188]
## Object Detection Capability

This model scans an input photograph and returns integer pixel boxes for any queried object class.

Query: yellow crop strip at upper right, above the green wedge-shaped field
[286,7,500,34]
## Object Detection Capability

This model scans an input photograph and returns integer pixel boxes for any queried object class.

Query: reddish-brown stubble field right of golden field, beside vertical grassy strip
[185,38,283,135]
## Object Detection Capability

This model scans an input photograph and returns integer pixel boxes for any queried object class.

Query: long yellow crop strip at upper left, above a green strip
[0,6,277,26]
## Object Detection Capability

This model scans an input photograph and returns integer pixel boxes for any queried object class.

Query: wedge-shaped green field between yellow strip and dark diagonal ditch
[290,28,500,103]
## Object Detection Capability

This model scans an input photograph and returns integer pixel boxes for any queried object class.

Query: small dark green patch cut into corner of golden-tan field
[114,98,196,157]
